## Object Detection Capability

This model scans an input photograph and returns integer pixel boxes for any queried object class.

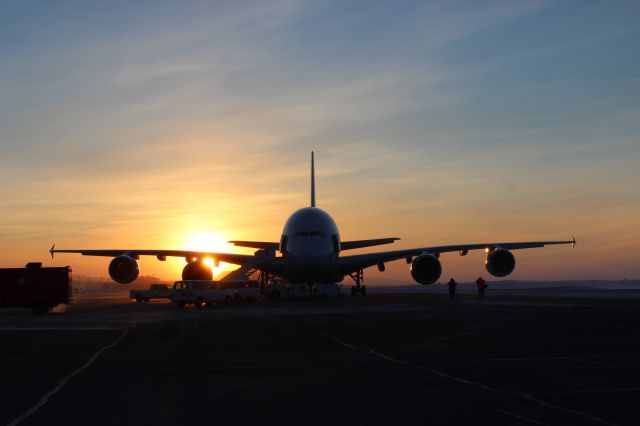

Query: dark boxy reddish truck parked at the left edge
[0,262,72,314]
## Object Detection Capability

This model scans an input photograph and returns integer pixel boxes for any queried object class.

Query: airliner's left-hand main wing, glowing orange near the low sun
[49,244,255,265]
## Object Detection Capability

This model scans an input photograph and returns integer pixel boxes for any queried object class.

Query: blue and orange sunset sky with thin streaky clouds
[0,0,640,283]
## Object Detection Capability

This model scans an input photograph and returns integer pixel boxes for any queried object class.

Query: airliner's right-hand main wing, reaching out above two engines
[338,237,576,275]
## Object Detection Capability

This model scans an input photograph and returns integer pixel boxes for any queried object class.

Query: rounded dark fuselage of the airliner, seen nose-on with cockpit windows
[280,207,343,283]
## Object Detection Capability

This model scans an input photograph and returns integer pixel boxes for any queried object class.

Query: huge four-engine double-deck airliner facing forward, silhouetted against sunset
[50,152,576,287]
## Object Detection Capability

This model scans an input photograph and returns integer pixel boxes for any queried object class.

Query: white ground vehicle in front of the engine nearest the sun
[171,280,233,309]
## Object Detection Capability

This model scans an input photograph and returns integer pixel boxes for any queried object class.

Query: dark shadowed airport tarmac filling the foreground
[0,286,640,425]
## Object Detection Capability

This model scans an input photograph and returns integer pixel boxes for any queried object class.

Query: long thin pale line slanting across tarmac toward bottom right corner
[319,333,617,426]
